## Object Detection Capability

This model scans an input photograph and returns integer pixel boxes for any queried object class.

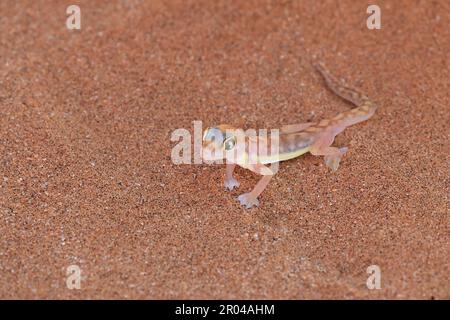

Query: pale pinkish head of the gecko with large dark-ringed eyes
[202,124,242,161]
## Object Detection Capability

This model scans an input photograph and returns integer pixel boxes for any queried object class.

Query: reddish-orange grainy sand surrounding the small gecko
[0,0,450,299]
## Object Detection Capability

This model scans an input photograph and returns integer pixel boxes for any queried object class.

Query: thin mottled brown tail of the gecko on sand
[313,62,377,111]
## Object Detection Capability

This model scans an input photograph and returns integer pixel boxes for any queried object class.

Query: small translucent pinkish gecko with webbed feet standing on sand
[202,63,377,209]
